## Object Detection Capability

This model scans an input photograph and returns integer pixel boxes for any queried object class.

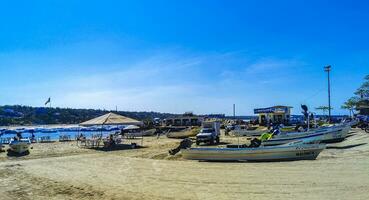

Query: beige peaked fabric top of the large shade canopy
[80,113,143,126]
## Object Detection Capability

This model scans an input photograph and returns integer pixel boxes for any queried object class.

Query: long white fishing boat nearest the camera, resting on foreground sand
[181,143,325,161]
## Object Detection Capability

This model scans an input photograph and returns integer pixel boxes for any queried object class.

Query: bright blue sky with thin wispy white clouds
[0,0,369,115]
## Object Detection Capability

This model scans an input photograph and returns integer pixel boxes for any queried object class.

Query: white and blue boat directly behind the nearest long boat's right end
[262,124,351,146]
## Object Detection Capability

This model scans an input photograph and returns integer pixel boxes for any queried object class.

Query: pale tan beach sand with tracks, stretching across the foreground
[0,129,369,200]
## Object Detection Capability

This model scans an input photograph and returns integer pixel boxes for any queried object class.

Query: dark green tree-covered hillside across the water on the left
[0,105,174,126]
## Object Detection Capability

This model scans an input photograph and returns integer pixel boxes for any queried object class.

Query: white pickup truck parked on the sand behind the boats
[196,122,220,145]
